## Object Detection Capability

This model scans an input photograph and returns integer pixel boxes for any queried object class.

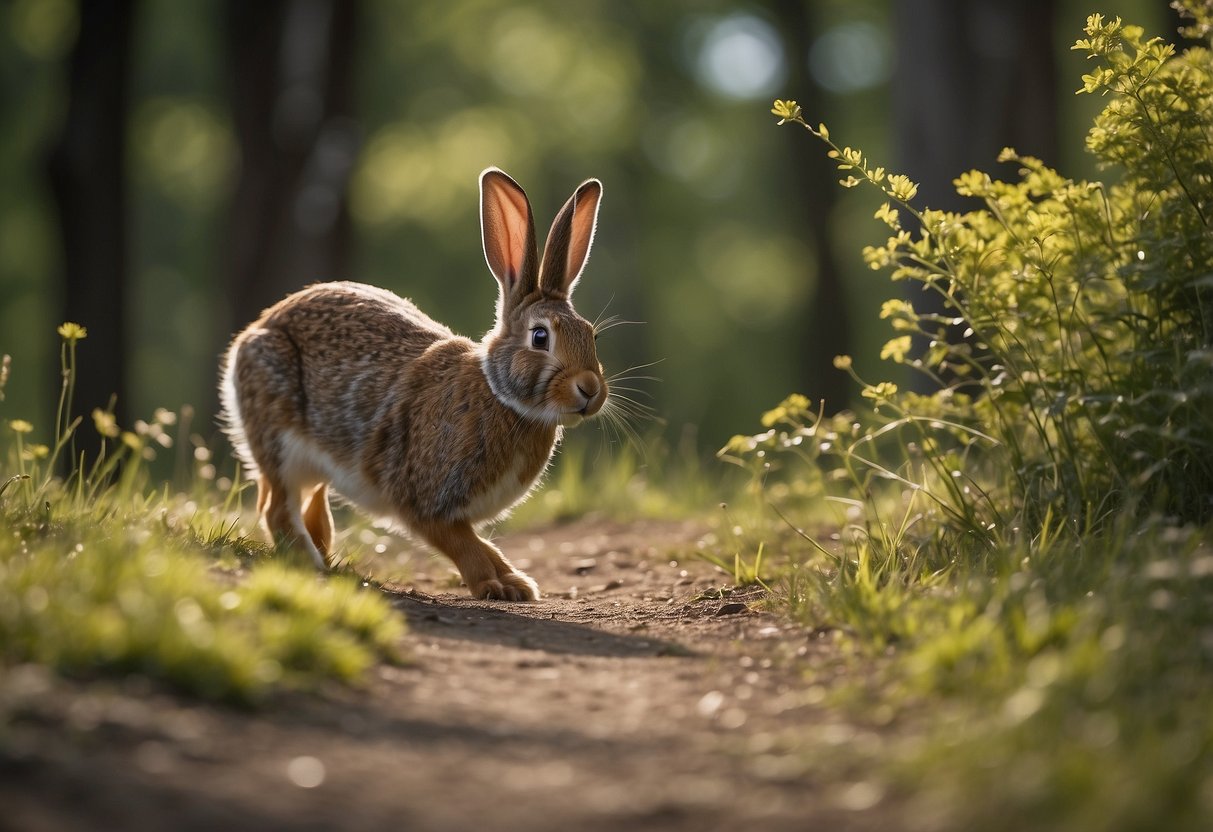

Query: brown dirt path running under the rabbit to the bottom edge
[0,522,876,831]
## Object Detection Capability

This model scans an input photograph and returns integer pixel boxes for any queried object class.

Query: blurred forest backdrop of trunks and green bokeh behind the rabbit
[0,0,1178,451]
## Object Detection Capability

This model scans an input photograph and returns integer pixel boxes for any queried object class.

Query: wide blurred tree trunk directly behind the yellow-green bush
[893,0,1058,389]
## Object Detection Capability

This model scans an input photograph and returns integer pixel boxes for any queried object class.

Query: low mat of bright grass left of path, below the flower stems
[0,509,404,702]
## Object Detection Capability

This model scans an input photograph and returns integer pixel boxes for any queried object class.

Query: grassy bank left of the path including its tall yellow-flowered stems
[0,325,404,702]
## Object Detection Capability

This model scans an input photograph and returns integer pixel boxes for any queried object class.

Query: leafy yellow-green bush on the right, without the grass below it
[756,15,1213,548]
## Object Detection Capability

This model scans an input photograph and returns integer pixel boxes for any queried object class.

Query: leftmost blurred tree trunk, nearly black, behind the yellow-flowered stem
[47,0,135,456]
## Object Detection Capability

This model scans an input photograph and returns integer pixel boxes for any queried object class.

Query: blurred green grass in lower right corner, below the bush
[761,511,1213,830]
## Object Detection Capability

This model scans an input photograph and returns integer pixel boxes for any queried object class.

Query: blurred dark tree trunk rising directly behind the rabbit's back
[224,0,360,337]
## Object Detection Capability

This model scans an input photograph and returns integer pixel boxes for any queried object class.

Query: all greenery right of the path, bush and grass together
[737,2,1213,830]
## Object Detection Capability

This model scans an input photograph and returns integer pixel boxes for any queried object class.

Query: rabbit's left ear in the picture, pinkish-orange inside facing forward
[480,167,537,297]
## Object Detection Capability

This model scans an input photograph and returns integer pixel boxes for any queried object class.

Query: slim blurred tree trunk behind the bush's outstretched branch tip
[773,0,852,412]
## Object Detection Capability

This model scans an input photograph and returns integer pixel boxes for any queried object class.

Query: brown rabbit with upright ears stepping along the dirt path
[221,167,608,602]
